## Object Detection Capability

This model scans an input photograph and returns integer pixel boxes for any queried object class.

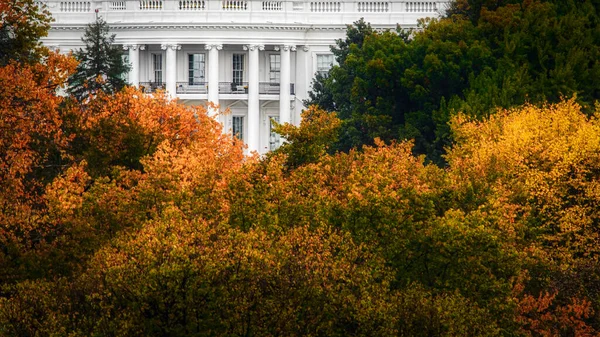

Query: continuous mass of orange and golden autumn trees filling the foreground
[0,0,600,336]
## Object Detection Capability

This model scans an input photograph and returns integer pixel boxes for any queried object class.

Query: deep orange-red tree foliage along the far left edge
[0,52,76,260]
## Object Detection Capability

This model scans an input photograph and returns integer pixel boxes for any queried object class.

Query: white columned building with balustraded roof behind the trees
[40,0,448,153]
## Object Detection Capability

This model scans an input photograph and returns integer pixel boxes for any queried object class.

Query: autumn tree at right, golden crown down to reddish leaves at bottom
[448,100,600,334]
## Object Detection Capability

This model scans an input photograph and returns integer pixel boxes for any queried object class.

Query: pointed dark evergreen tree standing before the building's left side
[69,18,130,100]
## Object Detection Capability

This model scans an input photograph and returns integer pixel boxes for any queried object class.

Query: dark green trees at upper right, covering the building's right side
[306,0,600,164]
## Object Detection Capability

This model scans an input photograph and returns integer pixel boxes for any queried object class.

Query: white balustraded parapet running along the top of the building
[36,0,450,27]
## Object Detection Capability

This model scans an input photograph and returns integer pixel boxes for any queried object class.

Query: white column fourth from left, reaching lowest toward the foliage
[244,44,265,152]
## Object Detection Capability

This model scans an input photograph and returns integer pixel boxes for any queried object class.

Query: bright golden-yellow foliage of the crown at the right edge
[447,99,600,262]
